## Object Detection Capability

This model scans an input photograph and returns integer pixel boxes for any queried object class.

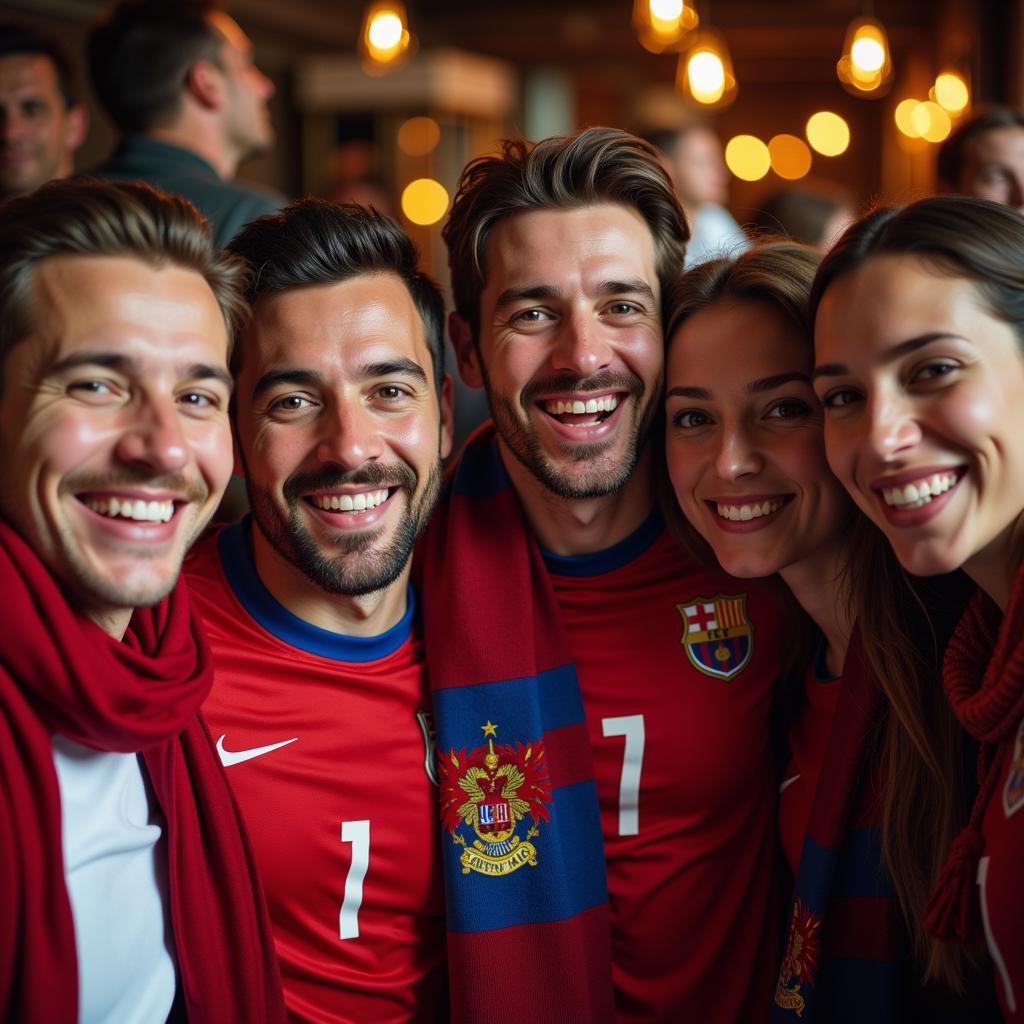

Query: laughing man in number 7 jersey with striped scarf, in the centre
[422,128,778,1022]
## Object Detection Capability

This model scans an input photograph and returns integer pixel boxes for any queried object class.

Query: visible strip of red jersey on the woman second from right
[778,647,843,874]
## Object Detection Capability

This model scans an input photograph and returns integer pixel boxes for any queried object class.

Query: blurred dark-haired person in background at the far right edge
[936,106,1024,212]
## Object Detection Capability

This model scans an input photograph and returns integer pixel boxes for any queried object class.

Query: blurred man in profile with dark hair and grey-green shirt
[88,0,285,247]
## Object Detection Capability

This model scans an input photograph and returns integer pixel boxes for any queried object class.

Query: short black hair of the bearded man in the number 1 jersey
[229,199,444,394]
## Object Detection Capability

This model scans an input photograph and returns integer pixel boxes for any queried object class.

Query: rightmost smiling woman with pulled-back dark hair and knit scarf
[812,197,1024,1021]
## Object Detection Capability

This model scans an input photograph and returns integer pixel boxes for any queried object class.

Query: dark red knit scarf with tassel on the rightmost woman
[925,566,1024,942]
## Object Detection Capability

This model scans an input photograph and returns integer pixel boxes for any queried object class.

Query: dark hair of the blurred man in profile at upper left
[86,0,224,132]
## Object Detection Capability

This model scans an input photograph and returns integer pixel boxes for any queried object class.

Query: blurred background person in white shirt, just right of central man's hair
[646,121,750,267]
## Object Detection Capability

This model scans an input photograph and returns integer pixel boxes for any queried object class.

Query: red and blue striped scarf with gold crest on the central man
[417,427,613,1024]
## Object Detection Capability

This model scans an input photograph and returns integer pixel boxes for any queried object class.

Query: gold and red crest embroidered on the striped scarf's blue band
[437,721,551,878]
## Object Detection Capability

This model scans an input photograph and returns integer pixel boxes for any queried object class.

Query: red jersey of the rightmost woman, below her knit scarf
[978,719,1024,1024]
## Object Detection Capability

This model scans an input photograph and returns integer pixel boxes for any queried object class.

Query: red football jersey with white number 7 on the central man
[546,517,782,1024]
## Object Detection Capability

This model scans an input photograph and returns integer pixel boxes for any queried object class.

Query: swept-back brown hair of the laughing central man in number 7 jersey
[441,128,689,338]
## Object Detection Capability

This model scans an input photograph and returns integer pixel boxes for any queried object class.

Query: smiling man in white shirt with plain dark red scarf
[0,181,283,1024]
